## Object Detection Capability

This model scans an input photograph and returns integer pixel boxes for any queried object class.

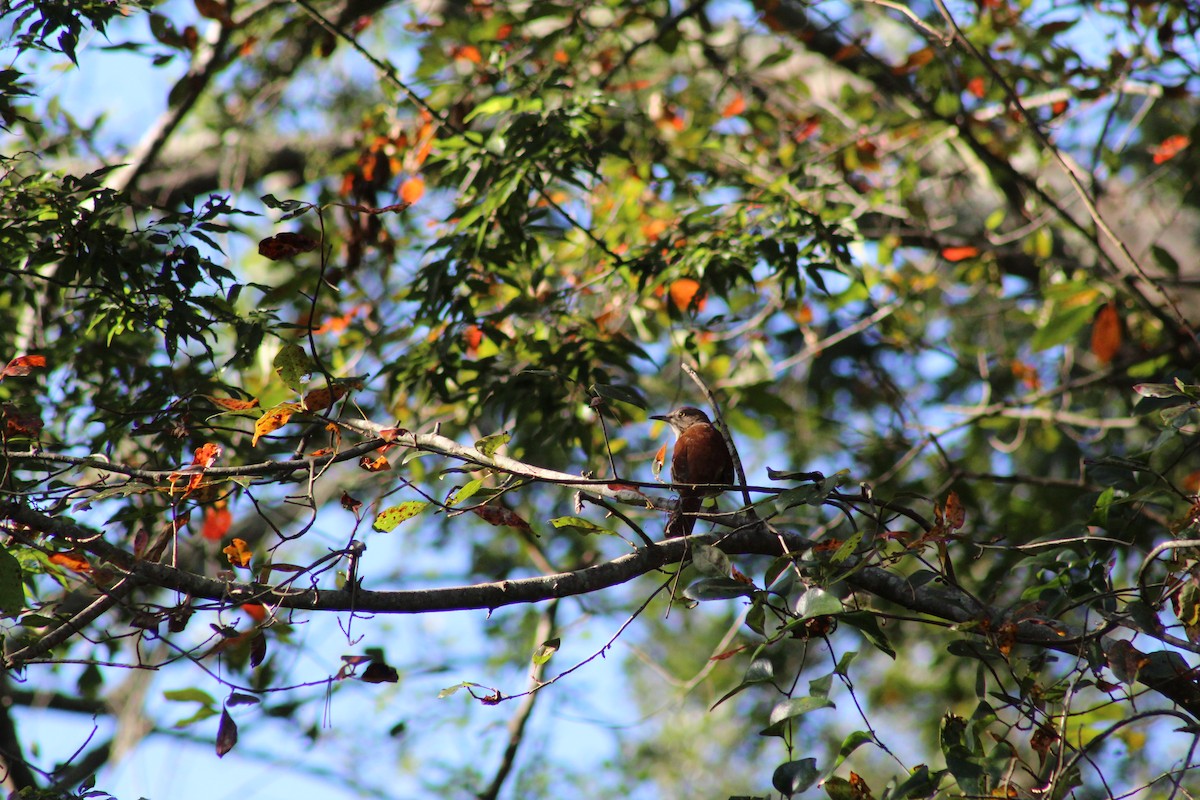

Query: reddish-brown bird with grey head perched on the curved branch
[650,405,733,539]
